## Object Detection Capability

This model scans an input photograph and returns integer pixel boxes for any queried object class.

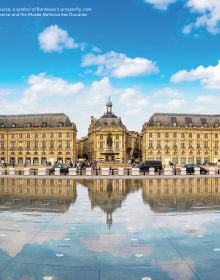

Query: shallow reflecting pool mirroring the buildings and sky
[0,177,220,280]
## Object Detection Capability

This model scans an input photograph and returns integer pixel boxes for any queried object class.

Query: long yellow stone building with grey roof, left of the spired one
[0,114,76,165]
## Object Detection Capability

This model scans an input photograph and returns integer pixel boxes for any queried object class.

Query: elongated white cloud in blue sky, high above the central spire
[81,51,159,78]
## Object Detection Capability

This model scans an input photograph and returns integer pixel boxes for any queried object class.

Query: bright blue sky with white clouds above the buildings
[0,0,220,136]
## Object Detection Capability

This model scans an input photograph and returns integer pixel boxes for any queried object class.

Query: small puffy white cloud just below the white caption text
[38,25,80,52]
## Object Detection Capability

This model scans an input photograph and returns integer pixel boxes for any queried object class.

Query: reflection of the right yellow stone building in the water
[143,178,220,212]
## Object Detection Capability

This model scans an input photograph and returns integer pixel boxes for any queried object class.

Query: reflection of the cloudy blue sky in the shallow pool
[0,179,220,280]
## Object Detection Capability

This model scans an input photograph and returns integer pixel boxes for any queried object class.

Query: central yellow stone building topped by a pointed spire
[77,99,139,162]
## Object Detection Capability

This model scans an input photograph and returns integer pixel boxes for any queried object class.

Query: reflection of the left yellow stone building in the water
[0,178,77,212]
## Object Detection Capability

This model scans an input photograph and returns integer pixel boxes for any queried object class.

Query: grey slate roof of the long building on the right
[147,113,220,127]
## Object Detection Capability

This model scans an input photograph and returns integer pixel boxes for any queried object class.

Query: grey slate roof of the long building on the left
[0,113,72,128]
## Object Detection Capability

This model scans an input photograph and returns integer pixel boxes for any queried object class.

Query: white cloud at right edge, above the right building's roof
[171,61,220,89]
